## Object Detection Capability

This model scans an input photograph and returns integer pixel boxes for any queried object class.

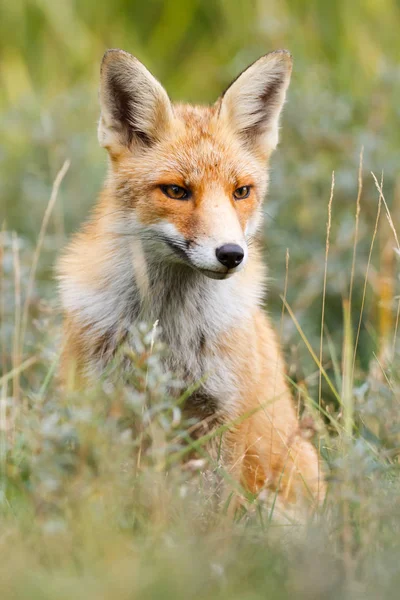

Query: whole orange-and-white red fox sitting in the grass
[58,50,325,507]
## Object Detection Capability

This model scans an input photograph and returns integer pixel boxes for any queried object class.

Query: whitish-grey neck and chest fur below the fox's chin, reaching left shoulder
[60,214,264,379]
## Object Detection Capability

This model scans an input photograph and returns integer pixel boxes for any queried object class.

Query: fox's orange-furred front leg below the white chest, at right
[216,311,325,507]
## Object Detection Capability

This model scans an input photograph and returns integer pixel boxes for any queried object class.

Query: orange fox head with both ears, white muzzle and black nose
[98,50,292,279]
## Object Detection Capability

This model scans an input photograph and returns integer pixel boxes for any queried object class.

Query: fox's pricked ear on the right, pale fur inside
[218,50,292,153]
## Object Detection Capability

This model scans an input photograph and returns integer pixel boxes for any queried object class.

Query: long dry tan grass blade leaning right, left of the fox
[20,160,70,353]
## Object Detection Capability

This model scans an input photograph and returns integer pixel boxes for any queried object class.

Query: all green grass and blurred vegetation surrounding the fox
[0,0,400,600]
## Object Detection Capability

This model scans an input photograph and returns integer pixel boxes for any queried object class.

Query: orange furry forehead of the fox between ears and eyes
[116,104,266,188]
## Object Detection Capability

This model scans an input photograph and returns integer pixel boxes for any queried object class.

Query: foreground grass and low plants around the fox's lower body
[0,157,400,599]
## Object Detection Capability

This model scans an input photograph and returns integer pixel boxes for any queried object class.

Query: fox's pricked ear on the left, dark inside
[98,50,172,152]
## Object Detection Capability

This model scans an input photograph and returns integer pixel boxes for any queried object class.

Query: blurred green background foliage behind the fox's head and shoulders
[0,0,400,384]
